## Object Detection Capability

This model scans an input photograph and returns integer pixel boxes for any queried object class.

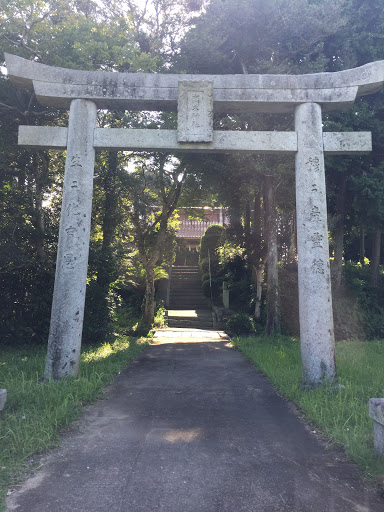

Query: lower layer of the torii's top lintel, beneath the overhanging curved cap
[33,81,358,113]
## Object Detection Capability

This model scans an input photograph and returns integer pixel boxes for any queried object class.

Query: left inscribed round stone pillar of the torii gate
[44,99,97,380]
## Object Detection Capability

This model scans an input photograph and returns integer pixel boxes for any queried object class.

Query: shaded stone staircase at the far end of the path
[168,266,213,329]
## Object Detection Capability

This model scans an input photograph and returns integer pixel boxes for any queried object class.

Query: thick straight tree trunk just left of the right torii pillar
[264,176,280,335]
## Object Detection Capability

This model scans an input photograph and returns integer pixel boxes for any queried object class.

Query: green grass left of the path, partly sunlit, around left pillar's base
[0,336,147,510]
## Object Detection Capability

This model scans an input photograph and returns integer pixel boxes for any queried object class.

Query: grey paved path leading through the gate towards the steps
[8,329,384,512]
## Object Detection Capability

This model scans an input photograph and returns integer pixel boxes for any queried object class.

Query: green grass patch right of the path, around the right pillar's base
[233,336,384,484]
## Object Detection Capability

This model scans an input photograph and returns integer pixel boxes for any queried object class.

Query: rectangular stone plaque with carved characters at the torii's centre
[177,81,213,142]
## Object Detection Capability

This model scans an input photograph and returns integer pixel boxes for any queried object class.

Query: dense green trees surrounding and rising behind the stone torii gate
[0,0,384,343]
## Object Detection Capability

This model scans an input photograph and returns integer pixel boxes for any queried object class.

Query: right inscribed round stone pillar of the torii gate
[295,103,336,386]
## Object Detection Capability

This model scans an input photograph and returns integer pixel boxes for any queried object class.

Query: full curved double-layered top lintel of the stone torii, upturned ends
[6,54,384,112]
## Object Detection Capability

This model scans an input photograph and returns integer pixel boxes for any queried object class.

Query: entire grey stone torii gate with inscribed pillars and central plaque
[6,54,384,385]
